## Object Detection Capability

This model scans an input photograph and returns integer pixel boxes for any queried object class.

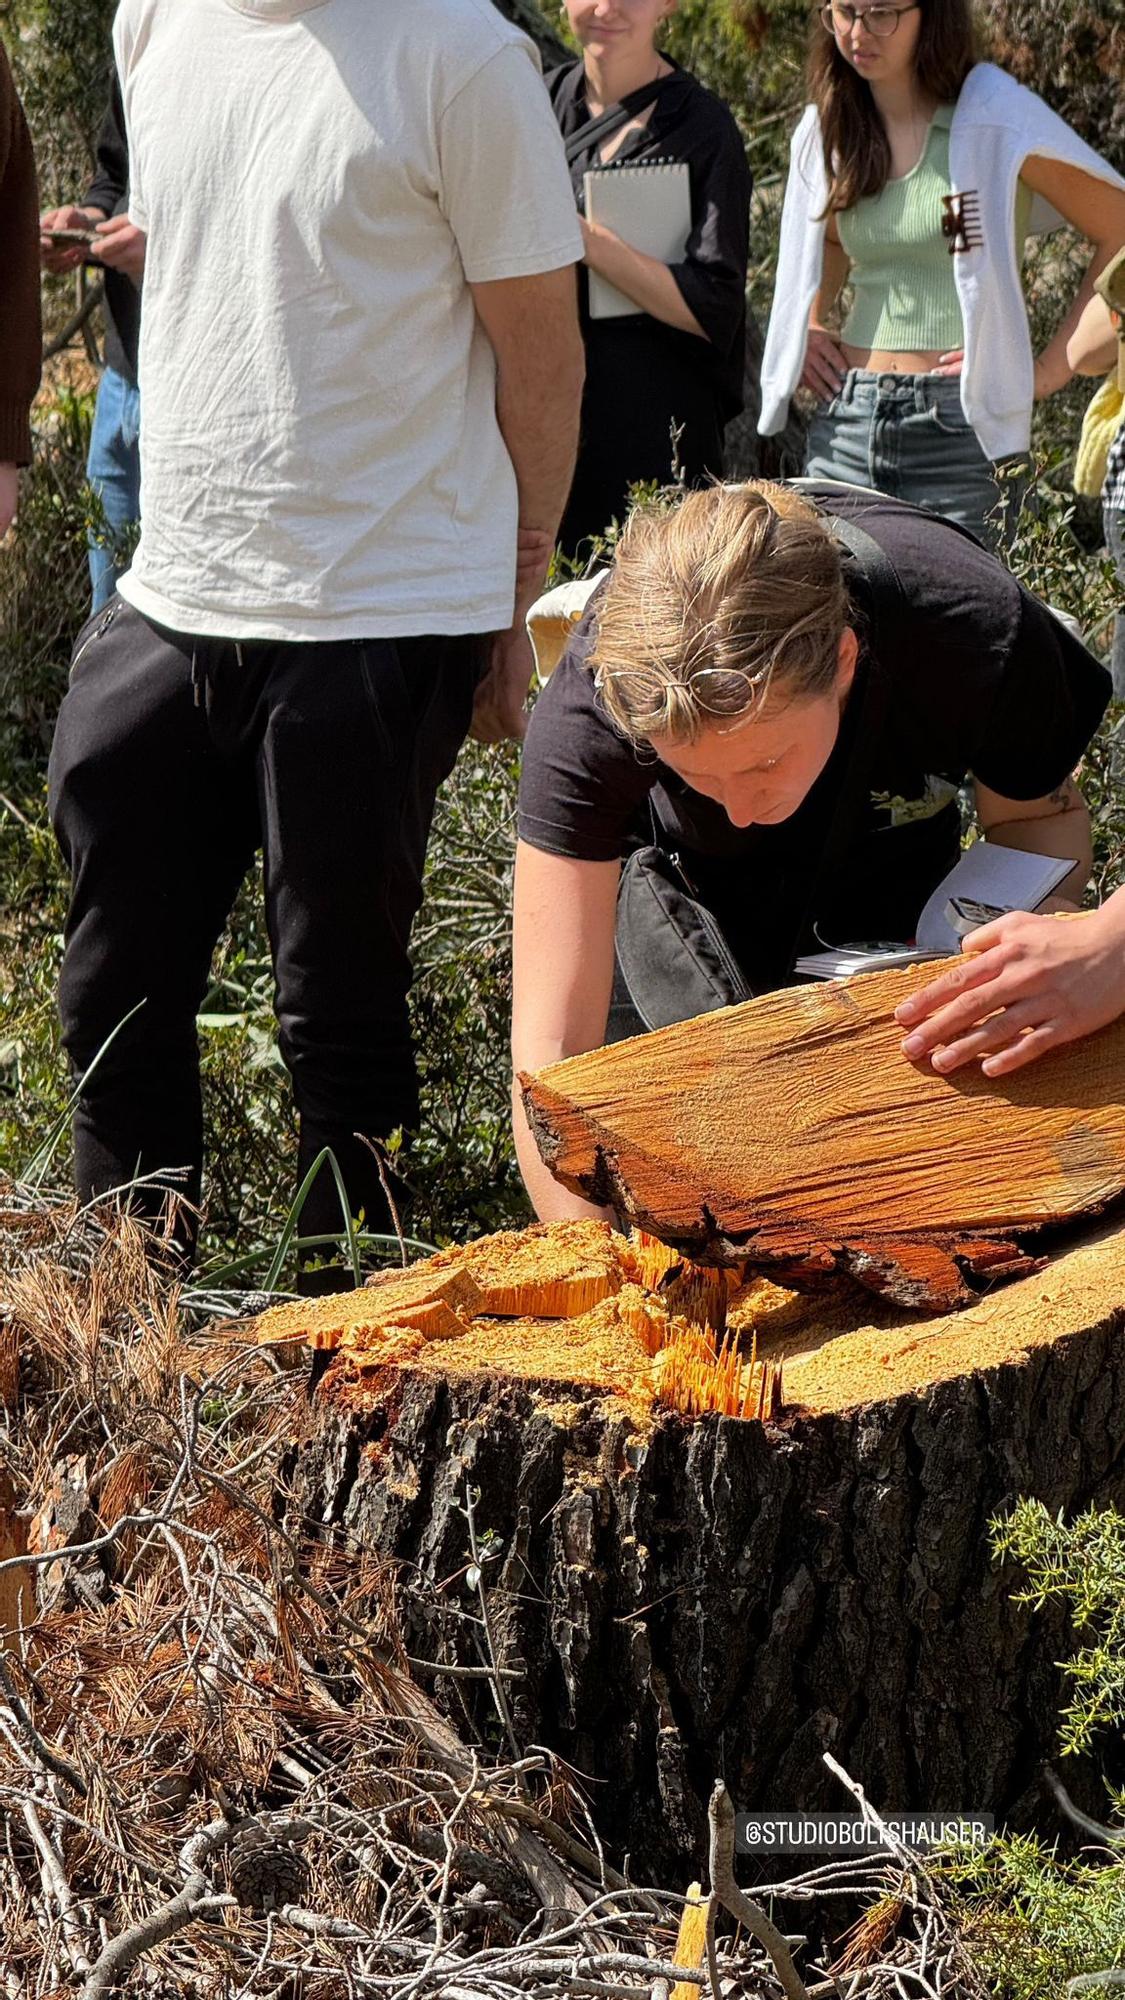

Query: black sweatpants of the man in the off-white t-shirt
[50,598,482,1234]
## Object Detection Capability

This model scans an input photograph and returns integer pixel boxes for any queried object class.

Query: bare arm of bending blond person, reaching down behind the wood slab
[512,840,621,1222]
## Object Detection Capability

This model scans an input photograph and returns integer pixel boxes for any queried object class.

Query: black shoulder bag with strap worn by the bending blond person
[615,514,903,1028]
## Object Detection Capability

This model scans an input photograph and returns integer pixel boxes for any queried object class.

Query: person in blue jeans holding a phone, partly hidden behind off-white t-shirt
[40,74,144,610]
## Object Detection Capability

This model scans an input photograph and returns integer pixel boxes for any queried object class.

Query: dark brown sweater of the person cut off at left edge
[0,44,42,466]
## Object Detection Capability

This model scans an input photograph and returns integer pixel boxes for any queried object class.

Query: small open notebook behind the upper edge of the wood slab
[793,840,1075,980]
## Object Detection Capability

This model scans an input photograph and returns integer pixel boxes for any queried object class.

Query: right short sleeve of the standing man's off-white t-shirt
[438,42,583,284]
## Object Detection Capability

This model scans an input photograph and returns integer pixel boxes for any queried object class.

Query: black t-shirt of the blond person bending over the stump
[518,488,1109,990]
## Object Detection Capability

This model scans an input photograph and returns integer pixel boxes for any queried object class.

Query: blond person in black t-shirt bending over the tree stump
[512,480,1109,1220]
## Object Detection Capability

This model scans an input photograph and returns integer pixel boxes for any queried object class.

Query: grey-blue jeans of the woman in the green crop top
[805,368,1021,552]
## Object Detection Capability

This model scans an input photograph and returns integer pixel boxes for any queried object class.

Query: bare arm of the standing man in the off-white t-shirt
[472,264,585,742]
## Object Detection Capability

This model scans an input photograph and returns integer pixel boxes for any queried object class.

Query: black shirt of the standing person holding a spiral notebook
[546,58,753,420]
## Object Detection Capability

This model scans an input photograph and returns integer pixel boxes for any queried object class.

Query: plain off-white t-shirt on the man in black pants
[114,0,583,640]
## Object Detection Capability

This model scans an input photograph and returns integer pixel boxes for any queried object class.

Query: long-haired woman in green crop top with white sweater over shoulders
[759,0,1125,546]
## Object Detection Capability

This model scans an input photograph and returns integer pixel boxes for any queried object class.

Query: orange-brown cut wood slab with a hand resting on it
[520,966,1125,1312]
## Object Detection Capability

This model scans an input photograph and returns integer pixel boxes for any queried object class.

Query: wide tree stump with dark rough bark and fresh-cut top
[274,1228,1125,1880]
